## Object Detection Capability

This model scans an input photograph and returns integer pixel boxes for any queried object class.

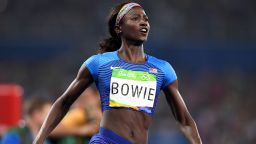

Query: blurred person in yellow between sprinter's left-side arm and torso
[51,88,102,144]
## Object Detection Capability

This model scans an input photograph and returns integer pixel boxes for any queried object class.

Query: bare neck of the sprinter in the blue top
[118,40,146,63]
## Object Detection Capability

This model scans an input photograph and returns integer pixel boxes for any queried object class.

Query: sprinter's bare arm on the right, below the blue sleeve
[163,80,202,144]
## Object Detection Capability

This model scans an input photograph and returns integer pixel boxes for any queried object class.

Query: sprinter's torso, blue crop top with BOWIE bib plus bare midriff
[85,51,177,144]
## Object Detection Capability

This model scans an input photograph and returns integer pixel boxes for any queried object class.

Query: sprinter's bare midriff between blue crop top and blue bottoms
[101,109,152,144]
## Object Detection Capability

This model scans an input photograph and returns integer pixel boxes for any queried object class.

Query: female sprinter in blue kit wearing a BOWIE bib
[34,3,202,144]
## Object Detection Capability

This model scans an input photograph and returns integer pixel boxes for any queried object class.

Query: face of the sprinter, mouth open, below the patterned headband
[120,7,150,42]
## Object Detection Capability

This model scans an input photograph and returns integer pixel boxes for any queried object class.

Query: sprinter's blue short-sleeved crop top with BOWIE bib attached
[84,51,177,116]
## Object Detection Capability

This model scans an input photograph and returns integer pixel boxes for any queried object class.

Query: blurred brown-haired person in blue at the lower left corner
[2,97,52,144]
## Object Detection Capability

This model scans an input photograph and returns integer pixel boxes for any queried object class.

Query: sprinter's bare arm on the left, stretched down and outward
[33,66,93,144]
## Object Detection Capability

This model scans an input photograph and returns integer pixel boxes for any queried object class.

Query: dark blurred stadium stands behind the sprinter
[0,0,256,144]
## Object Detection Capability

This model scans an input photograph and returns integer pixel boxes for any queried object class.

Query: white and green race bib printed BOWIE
[109,68,156,110]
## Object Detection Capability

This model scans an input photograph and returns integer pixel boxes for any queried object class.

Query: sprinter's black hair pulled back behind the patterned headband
[98,2,127,53]
